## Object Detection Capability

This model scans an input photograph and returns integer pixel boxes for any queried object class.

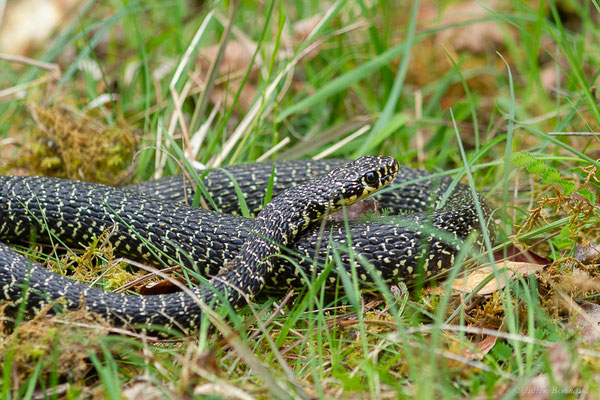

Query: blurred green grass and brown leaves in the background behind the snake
[0,0,598,183]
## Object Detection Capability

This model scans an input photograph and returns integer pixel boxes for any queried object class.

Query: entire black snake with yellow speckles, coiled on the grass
[0,158,494,333]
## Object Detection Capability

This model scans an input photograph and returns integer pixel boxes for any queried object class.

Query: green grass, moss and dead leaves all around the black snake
[0,0,600,399]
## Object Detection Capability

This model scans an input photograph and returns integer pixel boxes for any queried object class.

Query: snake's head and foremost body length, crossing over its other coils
[0,156,399,333]
